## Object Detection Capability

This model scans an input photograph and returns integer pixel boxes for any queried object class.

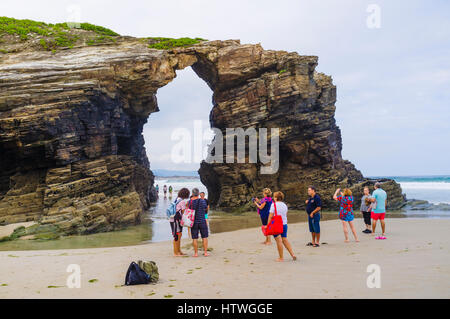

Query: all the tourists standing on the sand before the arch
[164,182,387,261]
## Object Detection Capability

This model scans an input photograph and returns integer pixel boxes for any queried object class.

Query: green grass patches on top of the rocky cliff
[0,17,206,54]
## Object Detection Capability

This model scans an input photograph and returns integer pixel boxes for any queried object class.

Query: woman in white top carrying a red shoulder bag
[265,192,297,261]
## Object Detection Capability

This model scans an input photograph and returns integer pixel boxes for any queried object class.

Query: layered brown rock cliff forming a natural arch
[0,38,403,234]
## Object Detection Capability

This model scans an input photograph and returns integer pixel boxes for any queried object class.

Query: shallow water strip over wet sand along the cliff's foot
[0,197,449,251]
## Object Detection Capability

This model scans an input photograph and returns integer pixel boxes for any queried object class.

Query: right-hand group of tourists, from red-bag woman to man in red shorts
[253,182,387,261]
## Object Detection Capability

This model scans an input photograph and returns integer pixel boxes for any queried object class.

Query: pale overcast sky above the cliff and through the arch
[4,0,450,176]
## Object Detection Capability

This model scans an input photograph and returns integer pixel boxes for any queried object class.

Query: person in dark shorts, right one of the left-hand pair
[188,188,209,257]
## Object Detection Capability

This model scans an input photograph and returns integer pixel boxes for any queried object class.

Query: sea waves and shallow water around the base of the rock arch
[0,176,450,250]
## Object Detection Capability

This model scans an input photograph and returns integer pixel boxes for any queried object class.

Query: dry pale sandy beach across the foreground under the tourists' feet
[0,218,450,299]
